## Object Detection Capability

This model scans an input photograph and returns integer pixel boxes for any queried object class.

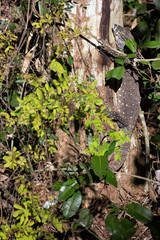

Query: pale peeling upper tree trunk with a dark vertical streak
[69,0,123,101]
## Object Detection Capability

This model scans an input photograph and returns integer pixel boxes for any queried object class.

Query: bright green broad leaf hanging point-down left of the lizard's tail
[91,156,108,180]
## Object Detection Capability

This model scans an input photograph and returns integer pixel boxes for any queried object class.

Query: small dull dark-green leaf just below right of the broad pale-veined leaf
[79,209,93,228]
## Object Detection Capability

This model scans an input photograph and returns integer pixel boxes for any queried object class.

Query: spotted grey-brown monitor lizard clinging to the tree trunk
[109,25,141,171]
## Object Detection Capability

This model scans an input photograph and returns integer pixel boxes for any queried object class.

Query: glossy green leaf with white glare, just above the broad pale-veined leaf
[58,178,79,200]
